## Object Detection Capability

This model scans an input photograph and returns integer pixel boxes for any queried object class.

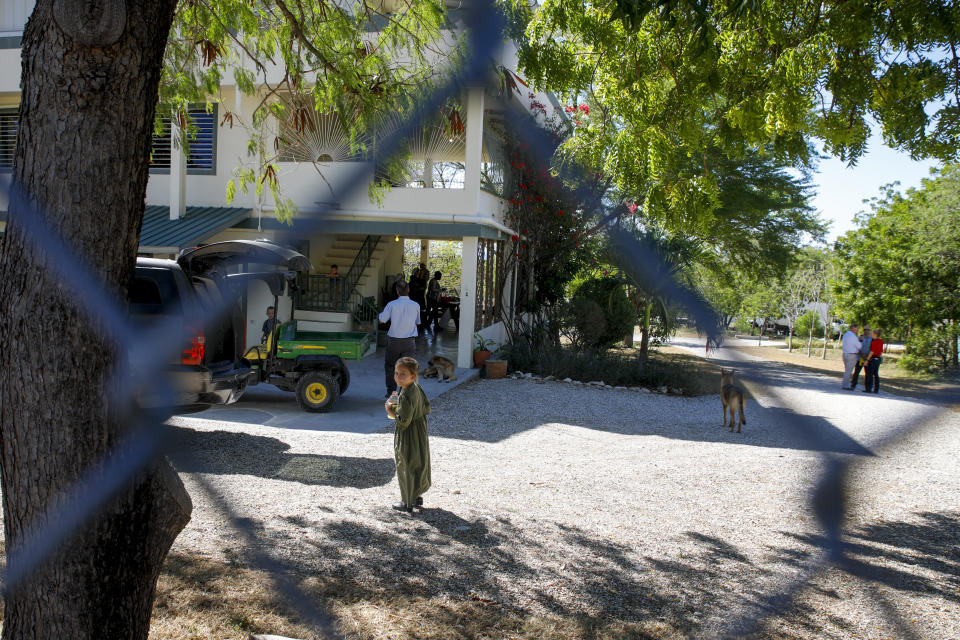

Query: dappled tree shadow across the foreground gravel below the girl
[158,509,960,640]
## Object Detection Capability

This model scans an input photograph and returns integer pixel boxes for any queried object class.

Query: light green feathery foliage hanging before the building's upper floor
[162,0,454,220]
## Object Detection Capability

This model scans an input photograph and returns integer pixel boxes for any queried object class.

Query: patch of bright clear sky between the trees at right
[811,131,939,244]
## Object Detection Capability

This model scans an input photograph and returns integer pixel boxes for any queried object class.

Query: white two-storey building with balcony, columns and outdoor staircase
[0,0,556,367]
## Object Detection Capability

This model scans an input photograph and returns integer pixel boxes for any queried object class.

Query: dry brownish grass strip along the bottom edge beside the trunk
[149,553,687,640]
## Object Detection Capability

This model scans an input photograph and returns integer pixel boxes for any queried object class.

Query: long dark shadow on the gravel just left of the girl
[168,426,396,489]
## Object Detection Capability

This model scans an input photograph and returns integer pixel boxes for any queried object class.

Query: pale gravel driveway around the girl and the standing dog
[171,354,960,638]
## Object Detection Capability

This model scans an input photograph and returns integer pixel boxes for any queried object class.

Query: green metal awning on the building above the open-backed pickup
[139,205,250,253]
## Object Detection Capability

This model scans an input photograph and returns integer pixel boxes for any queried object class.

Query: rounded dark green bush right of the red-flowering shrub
[564,278,636,349]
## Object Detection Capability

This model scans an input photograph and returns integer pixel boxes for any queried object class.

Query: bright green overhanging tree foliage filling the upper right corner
[520,0,960,277]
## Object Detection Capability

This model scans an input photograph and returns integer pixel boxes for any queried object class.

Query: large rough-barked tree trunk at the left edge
[0,0,190,640]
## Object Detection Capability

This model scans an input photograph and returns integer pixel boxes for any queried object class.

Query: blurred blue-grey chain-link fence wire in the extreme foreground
[3,1,948,638]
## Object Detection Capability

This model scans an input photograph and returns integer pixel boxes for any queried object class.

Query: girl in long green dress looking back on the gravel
[384,357,430,513]
